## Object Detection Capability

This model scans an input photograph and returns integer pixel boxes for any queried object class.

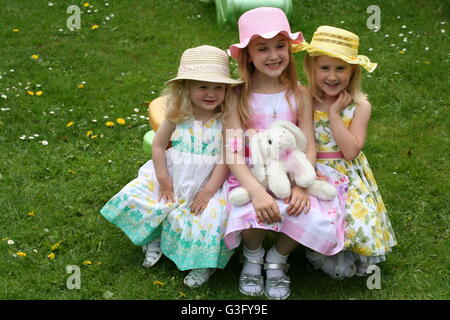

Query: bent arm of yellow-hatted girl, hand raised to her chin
[328,91,372,160]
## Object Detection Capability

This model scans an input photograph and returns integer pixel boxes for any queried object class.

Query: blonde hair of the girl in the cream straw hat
[161,79,231,124]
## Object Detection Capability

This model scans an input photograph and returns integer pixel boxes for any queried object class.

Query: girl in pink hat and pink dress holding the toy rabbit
[224,7,348,300]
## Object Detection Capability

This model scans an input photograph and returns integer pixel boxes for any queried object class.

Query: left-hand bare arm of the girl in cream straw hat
[152,120,175,202]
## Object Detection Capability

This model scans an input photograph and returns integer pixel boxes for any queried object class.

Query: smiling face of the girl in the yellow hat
[314,56,353,97]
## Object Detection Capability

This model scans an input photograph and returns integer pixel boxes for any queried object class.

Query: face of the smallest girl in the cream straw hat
[189,80,226,111]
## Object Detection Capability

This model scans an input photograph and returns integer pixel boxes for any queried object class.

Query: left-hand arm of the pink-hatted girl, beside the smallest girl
[224,87,281,223]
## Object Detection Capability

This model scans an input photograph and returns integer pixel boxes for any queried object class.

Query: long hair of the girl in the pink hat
[238,39,300,127]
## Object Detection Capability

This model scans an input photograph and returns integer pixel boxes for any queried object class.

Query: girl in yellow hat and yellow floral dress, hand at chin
[293,26,396,278]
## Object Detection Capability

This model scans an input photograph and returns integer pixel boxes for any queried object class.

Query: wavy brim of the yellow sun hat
[292,41,378,72]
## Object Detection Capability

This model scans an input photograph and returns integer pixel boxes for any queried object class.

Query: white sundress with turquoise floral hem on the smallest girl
[101,116,233,270]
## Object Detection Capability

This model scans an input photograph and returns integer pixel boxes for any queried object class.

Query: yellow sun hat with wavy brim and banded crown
[292,26,377,72]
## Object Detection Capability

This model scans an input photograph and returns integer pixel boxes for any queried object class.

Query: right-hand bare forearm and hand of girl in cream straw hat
[191,163,228,215]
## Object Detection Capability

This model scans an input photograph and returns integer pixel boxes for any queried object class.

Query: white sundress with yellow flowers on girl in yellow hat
[306,105,396,278]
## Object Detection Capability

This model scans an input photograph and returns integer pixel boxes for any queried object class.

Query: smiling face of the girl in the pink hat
[248,34,289,78]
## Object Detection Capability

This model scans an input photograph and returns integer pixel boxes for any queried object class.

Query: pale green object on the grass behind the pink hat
[215,0,292,25]
